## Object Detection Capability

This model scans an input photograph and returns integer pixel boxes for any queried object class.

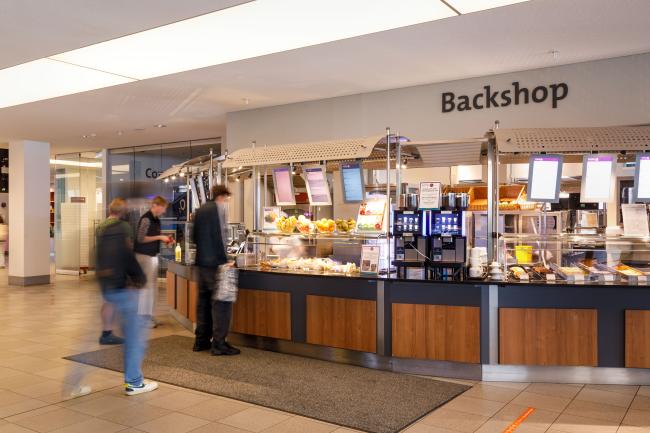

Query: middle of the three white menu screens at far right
[580,154,617,203]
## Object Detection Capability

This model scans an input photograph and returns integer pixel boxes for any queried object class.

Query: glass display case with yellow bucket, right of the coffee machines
[498,233,650,285]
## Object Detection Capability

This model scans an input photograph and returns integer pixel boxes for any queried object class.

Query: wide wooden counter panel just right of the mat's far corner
[499,308,598,367]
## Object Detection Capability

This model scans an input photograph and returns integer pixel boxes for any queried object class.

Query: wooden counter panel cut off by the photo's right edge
[625,310,650,368]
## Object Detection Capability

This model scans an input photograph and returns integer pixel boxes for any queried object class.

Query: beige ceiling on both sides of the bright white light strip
[0,0,650,153]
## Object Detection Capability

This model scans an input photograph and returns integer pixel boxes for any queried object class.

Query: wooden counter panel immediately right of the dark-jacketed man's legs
[232,289,291,340]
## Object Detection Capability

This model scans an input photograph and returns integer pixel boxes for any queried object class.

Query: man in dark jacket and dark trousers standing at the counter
[193,185,240,355]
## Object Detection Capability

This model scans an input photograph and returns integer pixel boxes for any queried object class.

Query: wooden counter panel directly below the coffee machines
[392,304,481,364]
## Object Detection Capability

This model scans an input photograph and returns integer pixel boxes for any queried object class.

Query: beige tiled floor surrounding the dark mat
[0,271,650,433]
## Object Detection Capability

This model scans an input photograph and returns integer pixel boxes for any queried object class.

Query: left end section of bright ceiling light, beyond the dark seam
[0,59,135,108]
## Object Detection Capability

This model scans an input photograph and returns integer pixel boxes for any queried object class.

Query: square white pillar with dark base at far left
[9,140,50,286]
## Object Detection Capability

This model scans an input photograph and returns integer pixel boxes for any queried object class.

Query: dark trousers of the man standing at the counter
[194,267,232,346]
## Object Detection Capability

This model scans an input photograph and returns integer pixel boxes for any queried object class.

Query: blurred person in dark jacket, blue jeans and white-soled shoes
[96,198,158,395]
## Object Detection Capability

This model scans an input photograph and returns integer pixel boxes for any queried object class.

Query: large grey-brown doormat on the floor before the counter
[67,336,468,433]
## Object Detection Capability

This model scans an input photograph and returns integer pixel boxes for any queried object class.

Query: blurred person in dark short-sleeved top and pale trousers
[134,196,172,328]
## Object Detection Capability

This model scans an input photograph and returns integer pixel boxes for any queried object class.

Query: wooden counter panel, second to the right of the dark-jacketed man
[307,295,377,353]
